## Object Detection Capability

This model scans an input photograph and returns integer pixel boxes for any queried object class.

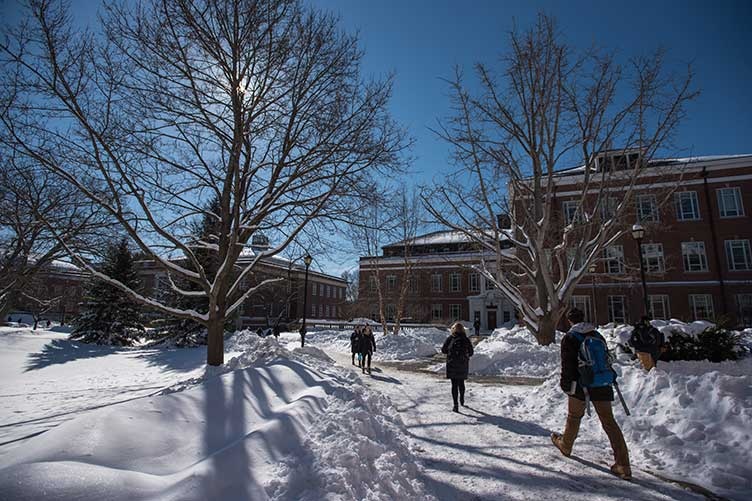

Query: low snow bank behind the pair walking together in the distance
[306,327,449,361]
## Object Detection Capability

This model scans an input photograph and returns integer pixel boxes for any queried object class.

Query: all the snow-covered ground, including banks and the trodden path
[0,327,752,500]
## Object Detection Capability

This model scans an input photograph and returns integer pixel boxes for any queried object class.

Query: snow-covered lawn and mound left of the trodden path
[0,330,431,500]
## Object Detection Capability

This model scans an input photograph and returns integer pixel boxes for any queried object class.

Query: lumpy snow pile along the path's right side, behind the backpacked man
[500,358,752,499]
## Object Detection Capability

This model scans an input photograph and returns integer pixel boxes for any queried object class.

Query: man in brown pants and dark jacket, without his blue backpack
[551,309,632,480]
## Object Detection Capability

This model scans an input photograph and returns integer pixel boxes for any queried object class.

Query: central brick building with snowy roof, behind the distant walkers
[358,231,514,330]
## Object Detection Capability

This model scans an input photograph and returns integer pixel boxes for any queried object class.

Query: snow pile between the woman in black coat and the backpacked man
[470,326,563,377]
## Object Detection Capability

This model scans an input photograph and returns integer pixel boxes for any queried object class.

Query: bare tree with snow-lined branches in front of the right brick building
[423,15,696,345]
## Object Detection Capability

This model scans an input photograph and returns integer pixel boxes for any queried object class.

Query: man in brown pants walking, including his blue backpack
[551,309,632,480]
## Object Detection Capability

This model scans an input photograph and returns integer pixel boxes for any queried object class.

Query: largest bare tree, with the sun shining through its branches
[0,0,404,365]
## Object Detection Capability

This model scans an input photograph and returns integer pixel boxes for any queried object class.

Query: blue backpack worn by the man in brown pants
[572,332,629,416]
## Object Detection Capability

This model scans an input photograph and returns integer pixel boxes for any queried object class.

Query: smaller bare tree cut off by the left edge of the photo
[0,154,108,318]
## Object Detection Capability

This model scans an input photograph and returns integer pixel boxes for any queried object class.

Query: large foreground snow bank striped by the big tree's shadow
[0,332,431,500]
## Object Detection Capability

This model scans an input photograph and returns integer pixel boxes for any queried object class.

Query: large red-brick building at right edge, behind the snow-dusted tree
[554,155,752,326]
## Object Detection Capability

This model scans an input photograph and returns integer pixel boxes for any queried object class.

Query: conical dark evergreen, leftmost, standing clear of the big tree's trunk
[70,239,145,346]
